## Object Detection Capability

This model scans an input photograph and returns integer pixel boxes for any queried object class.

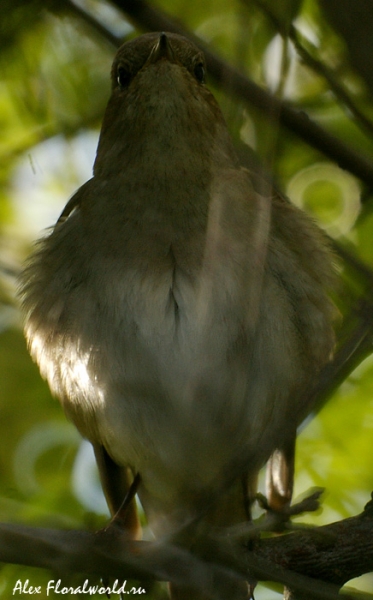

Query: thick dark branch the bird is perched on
[0,500,373,600]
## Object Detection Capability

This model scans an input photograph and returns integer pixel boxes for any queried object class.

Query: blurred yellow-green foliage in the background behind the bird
[0,0,373,600]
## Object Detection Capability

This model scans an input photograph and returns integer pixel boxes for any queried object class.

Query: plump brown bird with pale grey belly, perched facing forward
[19,32,335,600]
